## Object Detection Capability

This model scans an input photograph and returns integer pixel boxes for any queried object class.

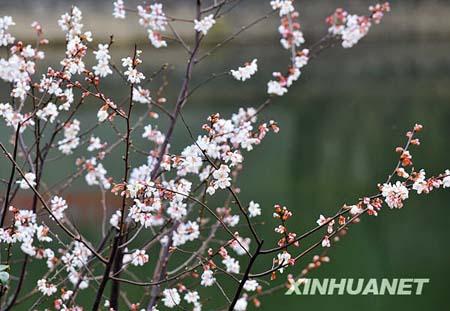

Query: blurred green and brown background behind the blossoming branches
[0,0,450,310]
